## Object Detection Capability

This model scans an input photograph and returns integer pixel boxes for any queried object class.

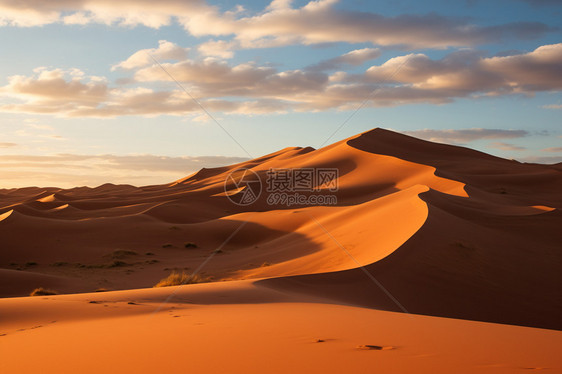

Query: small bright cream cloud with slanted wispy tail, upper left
[111,40,189,70]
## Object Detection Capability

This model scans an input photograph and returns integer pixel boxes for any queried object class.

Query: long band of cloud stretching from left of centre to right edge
[128,44,562,110]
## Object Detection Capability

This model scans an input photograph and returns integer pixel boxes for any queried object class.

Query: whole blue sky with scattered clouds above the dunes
[0,0,562,188]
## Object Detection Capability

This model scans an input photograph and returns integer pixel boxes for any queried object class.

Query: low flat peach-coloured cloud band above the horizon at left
[0,154,247,188]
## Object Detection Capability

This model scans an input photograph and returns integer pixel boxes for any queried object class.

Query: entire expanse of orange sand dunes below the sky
[0,129,562,373]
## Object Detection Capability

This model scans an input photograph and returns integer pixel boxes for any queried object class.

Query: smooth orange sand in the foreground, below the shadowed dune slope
[0,281,562,373]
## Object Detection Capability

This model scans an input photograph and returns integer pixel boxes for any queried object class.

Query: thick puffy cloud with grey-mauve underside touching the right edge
[366,43,562,97]
